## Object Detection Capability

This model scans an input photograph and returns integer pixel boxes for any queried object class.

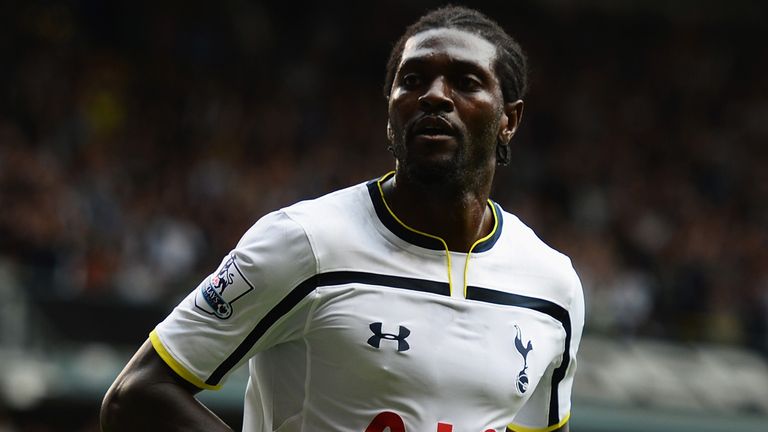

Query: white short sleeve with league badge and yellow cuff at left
[150,211,317,389]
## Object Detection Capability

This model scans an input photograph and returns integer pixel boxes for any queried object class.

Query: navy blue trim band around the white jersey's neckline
[366,174,504,252]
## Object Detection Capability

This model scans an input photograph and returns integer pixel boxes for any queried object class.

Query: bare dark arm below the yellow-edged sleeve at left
[100,340,232,432]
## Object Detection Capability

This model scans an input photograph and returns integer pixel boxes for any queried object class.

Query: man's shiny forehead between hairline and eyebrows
[400,28,496,69]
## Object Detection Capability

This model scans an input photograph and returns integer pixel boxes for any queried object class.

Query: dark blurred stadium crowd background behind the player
[0,0,768,432]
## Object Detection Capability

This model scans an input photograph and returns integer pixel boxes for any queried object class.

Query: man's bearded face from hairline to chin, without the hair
[389,29,508,185]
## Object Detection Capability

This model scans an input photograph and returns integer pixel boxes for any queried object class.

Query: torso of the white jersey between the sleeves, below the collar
[246,176,572,432]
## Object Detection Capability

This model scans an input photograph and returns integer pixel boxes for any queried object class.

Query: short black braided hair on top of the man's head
[384,5,528,103]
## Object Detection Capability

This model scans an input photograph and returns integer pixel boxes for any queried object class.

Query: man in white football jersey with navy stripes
[101,7,584,432]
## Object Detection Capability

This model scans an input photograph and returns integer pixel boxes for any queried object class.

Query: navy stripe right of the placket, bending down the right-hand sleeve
[467,286,571,426]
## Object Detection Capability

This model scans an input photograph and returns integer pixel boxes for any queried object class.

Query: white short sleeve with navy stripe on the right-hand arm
[509,267,584,432]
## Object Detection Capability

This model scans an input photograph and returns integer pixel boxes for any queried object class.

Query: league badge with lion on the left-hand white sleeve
[195,254,253,319]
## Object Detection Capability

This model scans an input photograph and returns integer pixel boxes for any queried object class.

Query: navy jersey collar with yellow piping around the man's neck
[366,171,504,252]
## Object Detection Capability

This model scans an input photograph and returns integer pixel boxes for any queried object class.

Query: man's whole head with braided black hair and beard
[384,6,527,190]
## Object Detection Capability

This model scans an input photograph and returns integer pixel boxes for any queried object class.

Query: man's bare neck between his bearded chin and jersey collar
[382,172,494,252]
